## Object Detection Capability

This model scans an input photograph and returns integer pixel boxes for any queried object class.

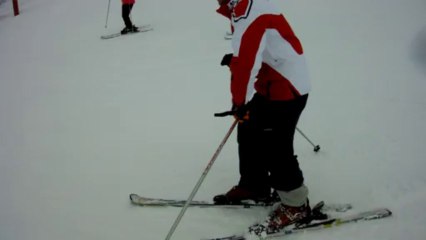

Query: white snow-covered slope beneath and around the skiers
[0,0,426,240]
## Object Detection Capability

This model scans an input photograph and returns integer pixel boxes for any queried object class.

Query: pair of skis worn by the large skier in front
[130,193,392,240]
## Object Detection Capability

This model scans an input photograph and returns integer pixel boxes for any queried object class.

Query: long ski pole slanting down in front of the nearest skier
[166,120,238,240]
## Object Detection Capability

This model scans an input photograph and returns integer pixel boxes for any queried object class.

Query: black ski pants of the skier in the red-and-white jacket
[237,94,308,195]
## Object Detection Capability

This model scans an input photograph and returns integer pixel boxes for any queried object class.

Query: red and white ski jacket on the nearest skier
[217,0,310,106]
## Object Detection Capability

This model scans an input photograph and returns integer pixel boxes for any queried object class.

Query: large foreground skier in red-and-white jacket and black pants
[214,0,311,235]
